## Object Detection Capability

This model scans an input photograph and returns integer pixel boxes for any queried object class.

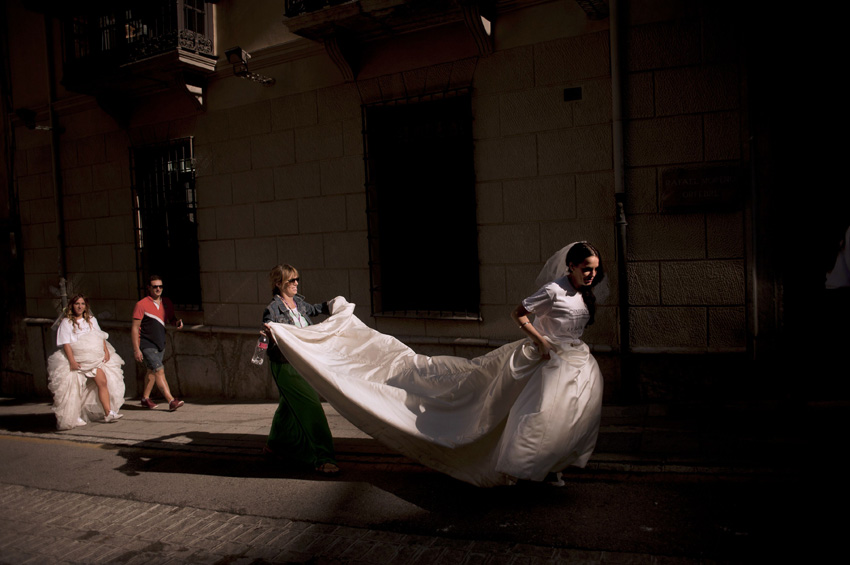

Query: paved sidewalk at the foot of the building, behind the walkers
[0,398,789,475]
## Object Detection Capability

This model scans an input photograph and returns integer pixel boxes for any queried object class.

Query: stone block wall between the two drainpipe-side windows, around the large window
[190,33,616,353]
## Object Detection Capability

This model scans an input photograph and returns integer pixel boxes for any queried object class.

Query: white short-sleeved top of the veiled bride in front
[522,276,590,341]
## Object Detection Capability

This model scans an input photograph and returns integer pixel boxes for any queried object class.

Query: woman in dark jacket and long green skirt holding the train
[263,265,339,475]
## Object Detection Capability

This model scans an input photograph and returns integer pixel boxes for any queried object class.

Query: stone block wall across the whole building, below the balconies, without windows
[8,0,747,398]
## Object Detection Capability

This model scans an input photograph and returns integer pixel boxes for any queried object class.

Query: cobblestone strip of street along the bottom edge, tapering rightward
[0,484,688,565]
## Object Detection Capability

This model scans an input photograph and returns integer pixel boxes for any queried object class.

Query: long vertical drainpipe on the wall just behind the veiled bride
[608,0,638,399]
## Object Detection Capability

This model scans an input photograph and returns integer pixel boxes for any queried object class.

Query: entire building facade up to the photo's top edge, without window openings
[2,0,792,401]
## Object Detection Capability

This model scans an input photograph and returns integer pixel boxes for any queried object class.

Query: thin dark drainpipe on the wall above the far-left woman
[44,14,68,309]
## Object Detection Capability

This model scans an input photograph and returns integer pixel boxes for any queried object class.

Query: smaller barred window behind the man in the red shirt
[131,137,201,310]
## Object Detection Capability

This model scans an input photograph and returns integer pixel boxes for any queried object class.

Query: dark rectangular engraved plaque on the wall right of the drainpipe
[661,165,744,212]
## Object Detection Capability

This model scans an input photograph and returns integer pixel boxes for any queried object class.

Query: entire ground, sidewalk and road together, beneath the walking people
[0,401,784,565]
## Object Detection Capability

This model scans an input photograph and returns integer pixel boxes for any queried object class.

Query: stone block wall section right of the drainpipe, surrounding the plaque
[625,10,747,352]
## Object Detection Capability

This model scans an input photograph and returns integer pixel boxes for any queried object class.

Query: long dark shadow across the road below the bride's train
[103,432,798,559]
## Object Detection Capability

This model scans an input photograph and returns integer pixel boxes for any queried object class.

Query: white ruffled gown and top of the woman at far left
[47,318,124,430]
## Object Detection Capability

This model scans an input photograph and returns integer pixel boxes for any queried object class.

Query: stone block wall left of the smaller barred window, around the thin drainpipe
[15,104,137,319]
